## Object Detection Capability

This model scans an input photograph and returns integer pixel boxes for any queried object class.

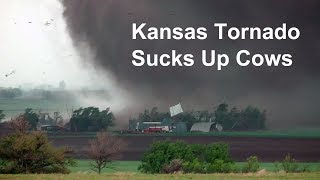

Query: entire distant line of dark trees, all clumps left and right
[0,103,266,132]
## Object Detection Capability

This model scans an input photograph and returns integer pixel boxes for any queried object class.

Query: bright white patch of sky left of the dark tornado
[0,0,110,88]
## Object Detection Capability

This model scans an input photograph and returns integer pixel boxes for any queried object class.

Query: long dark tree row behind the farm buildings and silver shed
[132,103,266,130]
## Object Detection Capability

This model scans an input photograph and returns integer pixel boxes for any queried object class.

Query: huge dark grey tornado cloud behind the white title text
[62,0,320,125]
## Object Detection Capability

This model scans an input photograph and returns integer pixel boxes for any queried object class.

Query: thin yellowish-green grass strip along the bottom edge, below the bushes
[0,172,320,180]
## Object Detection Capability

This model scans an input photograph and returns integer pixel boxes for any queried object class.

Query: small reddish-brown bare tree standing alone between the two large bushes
[88,131,127,174]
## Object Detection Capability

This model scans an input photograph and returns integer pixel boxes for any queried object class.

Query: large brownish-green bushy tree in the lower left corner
[0,116,74,173]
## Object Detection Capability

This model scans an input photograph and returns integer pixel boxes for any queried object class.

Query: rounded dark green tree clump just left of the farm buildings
[70,107,115,132]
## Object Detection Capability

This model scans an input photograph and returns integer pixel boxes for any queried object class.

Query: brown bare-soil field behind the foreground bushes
[51,136,320,162]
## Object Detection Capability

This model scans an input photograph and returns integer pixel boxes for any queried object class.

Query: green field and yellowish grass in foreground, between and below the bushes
[0,160,320,180]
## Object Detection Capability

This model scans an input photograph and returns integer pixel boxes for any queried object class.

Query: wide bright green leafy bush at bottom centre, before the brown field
[139,141,233,173]
